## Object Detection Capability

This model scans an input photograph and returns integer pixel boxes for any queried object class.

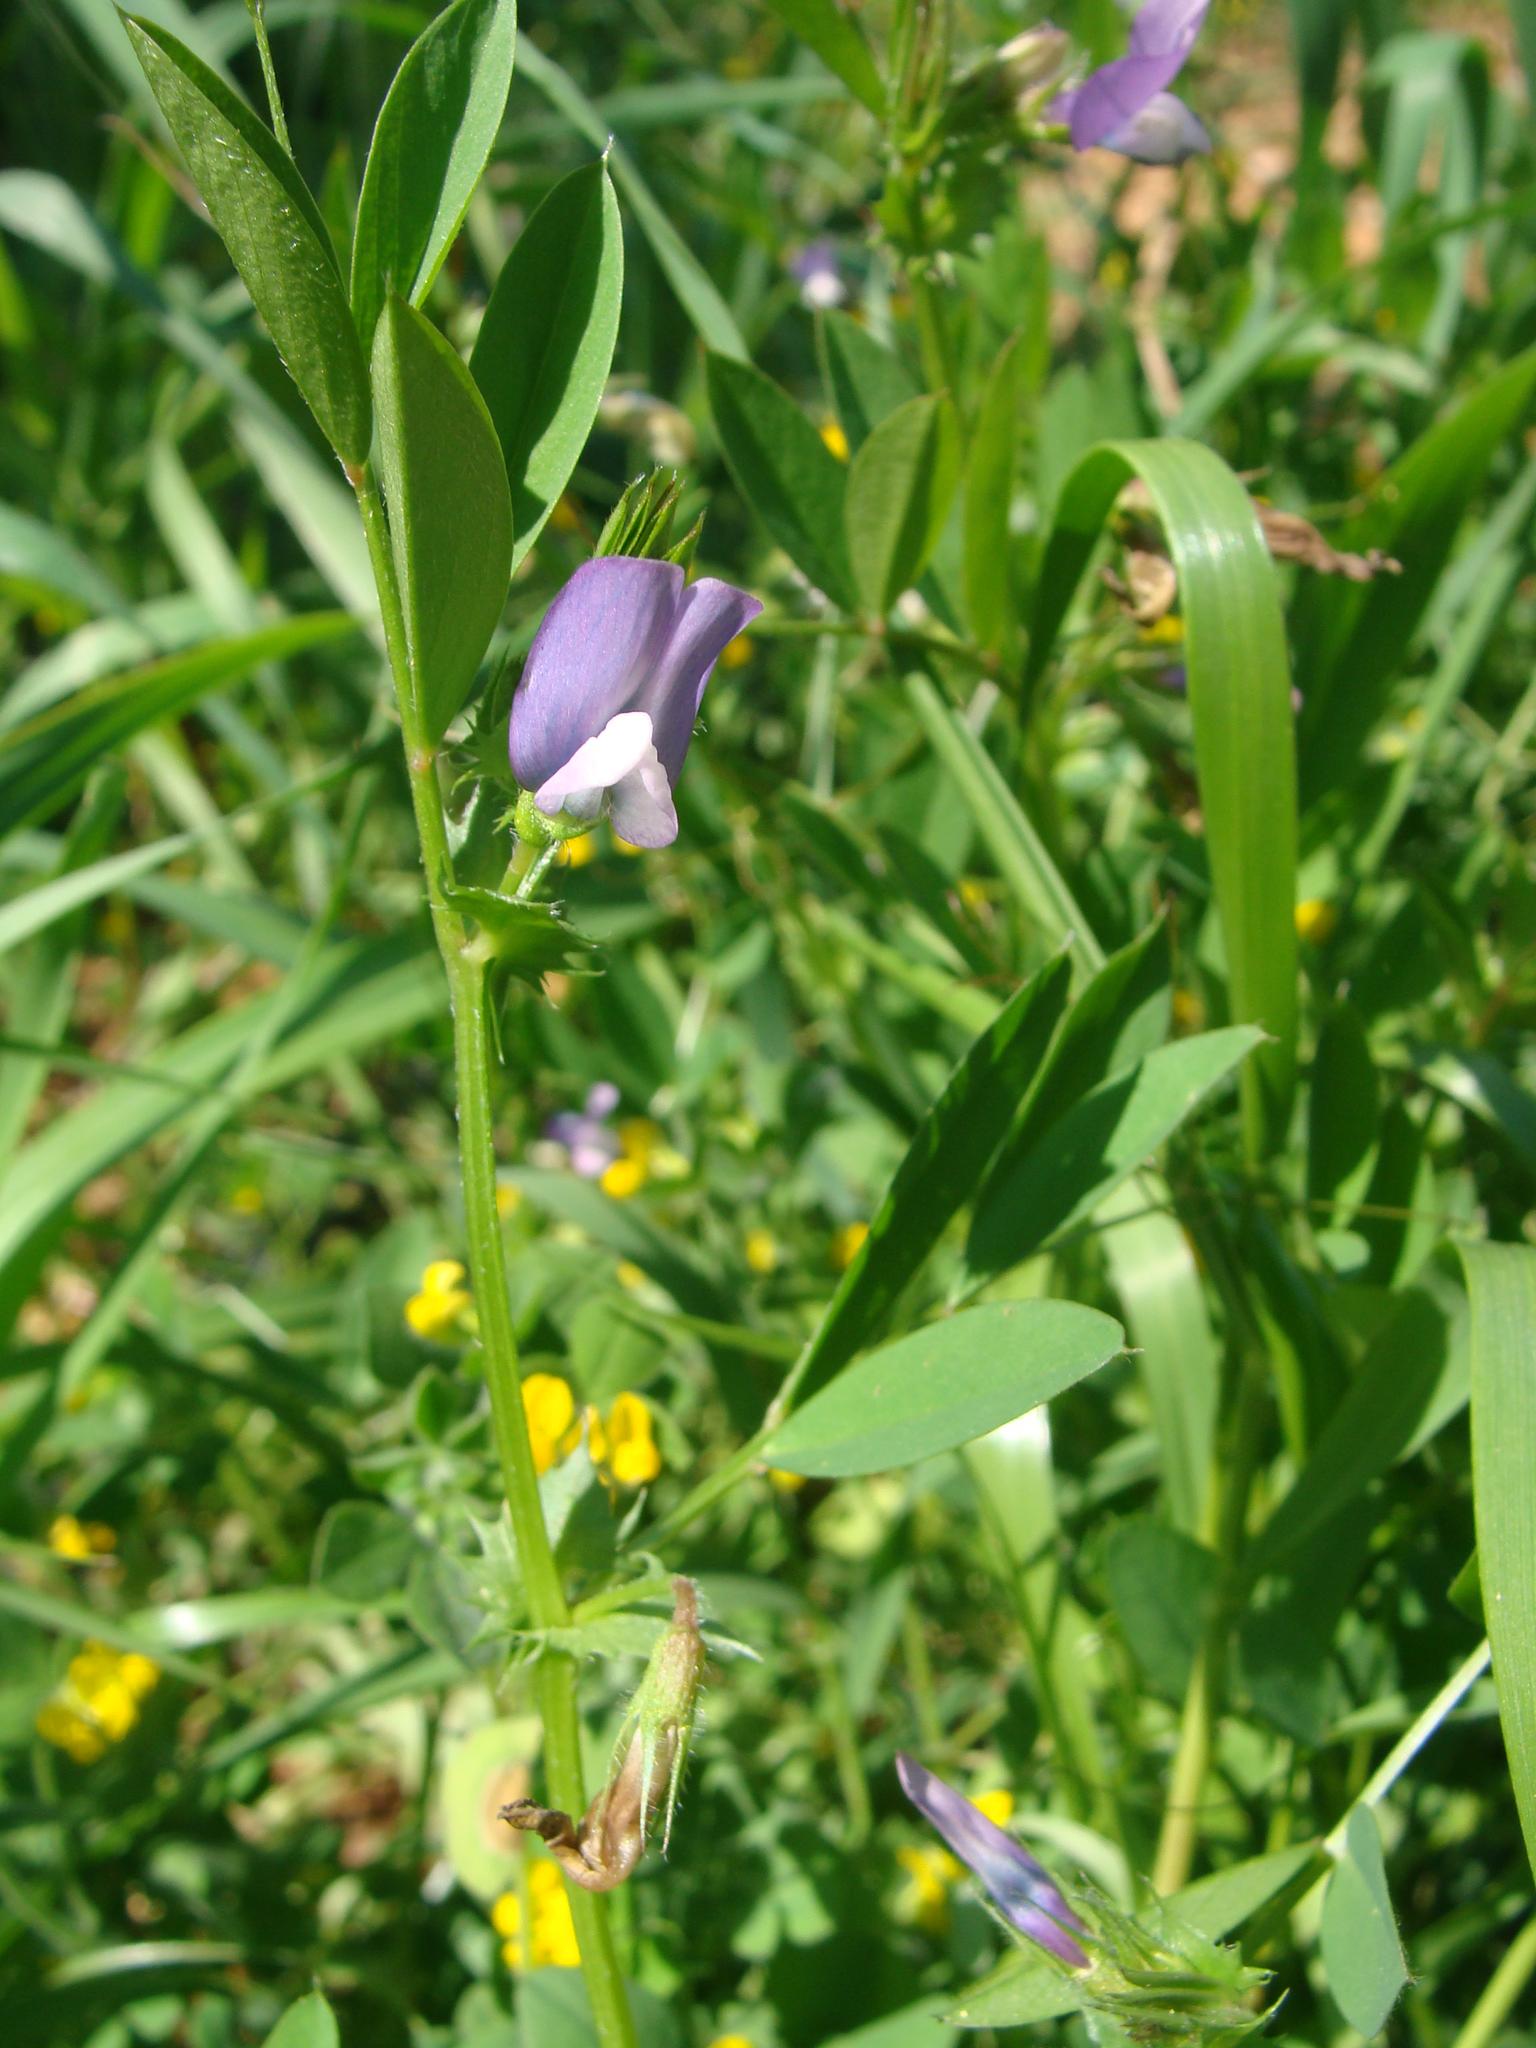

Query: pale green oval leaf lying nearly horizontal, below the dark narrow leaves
[760,1300,1124,1479]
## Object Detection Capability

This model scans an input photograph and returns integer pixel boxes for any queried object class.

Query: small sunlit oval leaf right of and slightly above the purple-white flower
[844,397,961,616]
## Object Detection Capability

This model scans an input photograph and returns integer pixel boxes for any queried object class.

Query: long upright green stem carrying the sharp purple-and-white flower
[356,467,635,2048]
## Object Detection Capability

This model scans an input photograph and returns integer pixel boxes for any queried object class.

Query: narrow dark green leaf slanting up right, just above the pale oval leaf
[776,954,1069,1415]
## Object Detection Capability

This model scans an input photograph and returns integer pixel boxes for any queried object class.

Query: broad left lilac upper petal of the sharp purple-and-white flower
[510,555,682,790]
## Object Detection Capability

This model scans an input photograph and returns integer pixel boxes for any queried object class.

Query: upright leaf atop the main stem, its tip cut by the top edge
[352,0,518,350]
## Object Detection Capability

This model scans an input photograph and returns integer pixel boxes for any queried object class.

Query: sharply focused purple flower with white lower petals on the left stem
[508,555,762,846]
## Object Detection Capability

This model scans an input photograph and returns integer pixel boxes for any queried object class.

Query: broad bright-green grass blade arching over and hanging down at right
[1028,440,1302,1159]
